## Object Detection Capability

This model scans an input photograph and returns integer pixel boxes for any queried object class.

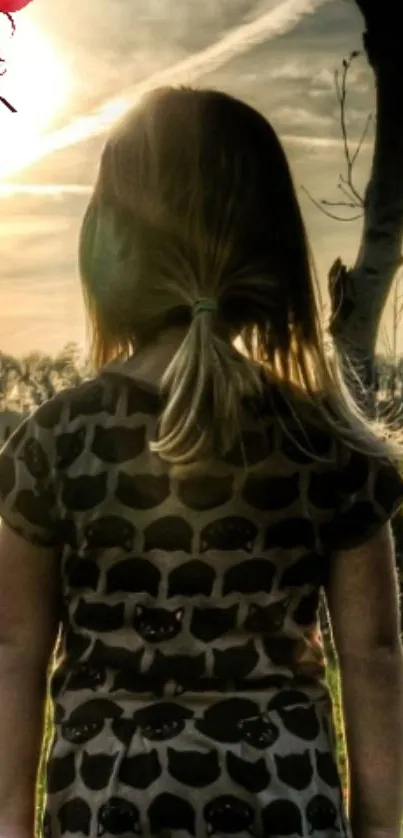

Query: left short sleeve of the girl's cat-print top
[0,402,59,547]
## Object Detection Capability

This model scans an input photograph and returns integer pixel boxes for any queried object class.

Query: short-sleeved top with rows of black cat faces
[0,372,403,838]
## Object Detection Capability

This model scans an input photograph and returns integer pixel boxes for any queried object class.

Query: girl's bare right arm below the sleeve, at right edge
[326,524,403,838]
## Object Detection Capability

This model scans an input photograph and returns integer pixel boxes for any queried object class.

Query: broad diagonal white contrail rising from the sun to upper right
[0,0,325,178]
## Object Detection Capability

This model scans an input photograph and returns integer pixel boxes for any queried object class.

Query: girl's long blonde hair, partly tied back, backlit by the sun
[80,88,400,480]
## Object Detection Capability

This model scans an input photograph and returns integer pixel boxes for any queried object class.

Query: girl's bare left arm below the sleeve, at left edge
[0,522,59,838]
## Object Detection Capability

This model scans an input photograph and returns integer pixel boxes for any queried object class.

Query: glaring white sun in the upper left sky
[0,13,71,179]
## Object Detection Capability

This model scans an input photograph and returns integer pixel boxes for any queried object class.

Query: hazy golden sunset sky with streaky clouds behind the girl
[0,0,403,355]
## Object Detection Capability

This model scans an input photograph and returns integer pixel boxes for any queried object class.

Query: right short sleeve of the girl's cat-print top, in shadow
[321,445,403,552]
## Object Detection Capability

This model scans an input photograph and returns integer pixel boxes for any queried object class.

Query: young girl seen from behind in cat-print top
[0,89,403,838]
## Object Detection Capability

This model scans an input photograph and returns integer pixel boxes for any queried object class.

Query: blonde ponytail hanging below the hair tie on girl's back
[150,309,263,477]
